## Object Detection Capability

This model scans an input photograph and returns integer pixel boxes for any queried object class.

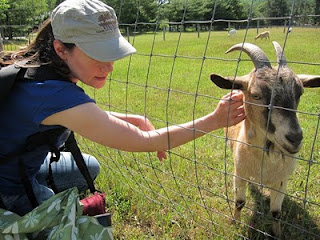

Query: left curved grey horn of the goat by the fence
[226,43,272,69]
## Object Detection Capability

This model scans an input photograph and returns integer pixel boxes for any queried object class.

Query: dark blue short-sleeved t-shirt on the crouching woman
[0,80,95,193]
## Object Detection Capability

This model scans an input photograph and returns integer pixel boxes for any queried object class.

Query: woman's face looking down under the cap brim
[55,41,114,89]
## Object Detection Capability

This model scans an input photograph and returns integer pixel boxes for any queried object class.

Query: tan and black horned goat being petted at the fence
[210,42,320,236]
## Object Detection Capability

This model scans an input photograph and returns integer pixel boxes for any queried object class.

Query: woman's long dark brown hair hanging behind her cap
[0,19,75,78]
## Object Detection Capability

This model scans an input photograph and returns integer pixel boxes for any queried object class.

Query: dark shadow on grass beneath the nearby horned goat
[243,186,320,240]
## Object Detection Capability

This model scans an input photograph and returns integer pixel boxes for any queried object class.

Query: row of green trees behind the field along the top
[0,0,320,38]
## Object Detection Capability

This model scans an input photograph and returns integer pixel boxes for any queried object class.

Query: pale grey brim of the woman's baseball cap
[75,35,136,62]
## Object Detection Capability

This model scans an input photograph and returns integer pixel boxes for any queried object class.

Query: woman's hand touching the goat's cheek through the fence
[214,90,245,128]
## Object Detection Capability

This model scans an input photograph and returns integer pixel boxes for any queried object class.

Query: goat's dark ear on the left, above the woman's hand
[210,74,247,90]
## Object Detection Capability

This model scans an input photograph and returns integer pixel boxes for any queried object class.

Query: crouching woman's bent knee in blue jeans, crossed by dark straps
[36,152,100,192]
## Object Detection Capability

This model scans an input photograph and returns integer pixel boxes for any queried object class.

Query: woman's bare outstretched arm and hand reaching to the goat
[42,92,245,152]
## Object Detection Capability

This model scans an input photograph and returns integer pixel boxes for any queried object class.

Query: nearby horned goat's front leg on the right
[270,181,287,237]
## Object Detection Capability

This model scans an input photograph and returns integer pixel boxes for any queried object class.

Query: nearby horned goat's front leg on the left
[233,175,247,221]
